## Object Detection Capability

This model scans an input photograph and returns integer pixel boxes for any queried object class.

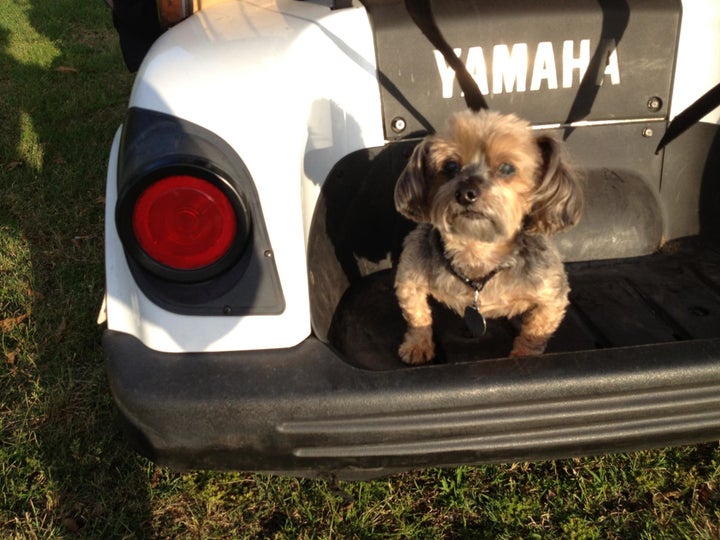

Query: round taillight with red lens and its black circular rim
[118,165,250,282]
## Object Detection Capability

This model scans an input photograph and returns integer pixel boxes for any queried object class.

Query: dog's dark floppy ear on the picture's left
[395,137,432,223]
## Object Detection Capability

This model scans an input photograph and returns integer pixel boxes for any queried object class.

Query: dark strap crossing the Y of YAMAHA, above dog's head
[405,0,488,111]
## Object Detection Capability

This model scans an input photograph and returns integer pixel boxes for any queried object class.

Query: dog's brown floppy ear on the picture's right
[525,135,583,234]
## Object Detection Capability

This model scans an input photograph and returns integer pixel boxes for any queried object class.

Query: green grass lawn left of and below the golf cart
[0,0,720,539]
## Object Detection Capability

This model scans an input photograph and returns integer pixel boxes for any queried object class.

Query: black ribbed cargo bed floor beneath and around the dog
[329,237,720,370]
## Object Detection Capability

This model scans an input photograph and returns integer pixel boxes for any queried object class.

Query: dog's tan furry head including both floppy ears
[395,111,582,242]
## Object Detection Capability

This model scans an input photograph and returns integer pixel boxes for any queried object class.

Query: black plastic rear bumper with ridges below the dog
[104,331,720,479]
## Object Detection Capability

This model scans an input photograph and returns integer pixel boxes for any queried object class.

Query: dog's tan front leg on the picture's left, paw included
[395,283,435,365]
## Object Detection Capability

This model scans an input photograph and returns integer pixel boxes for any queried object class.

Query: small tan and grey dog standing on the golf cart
[395,111,583,364]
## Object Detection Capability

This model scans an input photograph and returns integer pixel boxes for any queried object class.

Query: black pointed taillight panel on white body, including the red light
[115,107,285,315]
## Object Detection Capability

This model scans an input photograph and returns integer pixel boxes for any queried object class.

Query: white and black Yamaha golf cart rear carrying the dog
[104,0,720,478]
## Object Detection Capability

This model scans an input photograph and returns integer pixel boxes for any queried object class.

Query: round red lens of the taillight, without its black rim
[132,175,238,270]
